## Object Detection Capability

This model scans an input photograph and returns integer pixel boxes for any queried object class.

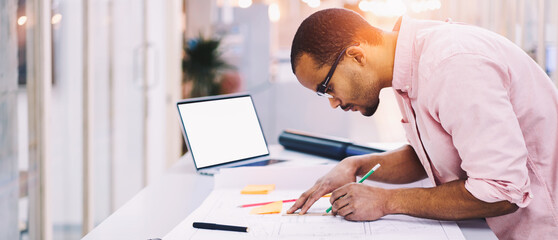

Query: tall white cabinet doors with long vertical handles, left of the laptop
[49,0,181,234]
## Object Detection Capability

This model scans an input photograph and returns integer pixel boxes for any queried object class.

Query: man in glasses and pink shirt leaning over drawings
[288,9,558,239]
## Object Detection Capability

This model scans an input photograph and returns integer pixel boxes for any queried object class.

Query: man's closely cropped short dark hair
[291,8,382,73]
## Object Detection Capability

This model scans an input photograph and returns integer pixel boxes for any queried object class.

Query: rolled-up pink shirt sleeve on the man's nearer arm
[428,54,531,207]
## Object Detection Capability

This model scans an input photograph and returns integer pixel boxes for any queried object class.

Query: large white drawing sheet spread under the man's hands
[163,166,464,240]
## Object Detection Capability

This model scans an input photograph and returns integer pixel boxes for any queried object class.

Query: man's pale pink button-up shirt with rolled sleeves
[392,17,558,239]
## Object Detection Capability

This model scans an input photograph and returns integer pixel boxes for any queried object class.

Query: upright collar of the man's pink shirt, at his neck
[391,16,416,95]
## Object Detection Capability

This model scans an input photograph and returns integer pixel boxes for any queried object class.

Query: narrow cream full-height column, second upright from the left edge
[26,0,52,240]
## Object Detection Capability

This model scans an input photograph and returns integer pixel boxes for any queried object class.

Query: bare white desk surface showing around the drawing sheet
[82,146,498,240]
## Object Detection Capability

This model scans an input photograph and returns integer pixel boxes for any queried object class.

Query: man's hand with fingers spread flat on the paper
[287,157,358,214]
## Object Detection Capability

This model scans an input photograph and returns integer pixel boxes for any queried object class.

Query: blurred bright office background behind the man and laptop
[0,0,558,239]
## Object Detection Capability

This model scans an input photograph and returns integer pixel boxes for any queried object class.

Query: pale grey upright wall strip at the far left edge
[0,0,19,239]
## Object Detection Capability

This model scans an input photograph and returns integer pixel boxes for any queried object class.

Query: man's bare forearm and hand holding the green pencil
[330,180,518,221]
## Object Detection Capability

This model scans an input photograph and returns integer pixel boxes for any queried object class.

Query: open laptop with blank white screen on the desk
[176,94,285,175]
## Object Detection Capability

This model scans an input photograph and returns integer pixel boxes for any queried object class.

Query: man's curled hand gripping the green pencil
[329,183,389,221]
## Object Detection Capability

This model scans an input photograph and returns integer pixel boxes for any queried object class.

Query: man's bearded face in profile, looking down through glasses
[296,53,381,116]
